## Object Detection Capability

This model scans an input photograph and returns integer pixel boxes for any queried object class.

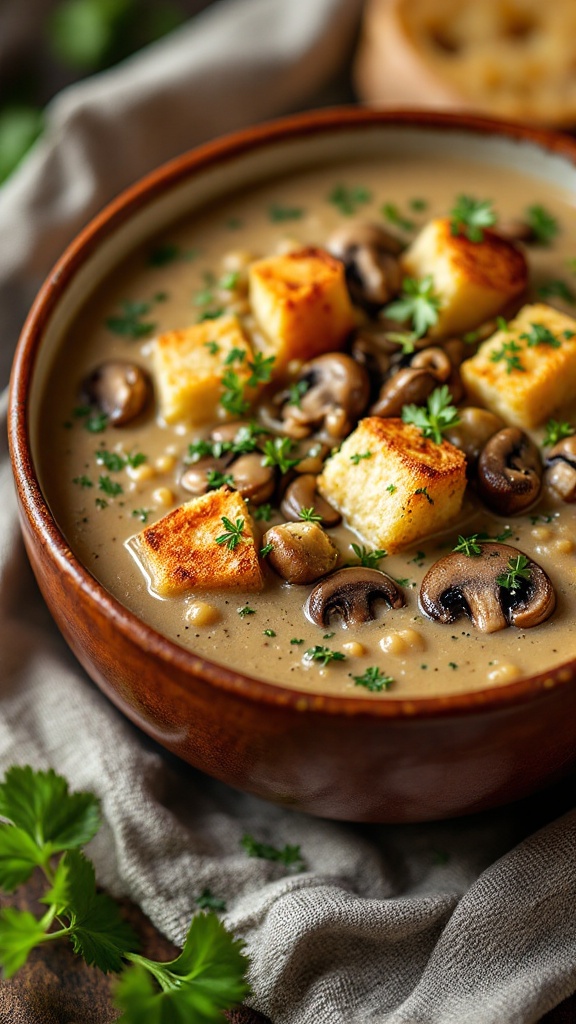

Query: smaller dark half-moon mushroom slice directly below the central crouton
[304,565,405,627]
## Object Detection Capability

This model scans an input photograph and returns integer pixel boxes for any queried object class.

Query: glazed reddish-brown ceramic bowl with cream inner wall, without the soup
[9,109,576,822]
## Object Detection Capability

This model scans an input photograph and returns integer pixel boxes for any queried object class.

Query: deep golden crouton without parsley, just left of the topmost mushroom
[249,248,355,375]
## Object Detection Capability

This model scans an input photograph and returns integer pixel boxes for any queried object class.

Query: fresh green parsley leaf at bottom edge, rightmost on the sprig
[114,913,250,1024]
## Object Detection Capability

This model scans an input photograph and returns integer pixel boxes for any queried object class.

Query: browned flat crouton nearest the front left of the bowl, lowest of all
[126,487,263,597]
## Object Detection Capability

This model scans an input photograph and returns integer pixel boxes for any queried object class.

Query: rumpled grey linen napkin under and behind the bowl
[0,0,576,1024]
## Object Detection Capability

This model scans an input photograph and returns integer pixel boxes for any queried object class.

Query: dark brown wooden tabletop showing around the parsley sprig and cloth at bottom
[0,881,576,1024]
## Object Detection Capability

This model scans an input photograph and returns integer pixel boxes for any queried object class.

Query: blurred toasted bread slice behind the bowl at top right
[355,0,576,126]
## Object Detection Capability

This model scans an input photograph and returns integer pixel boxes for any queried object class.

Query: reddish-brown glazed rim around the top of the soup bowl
[8,106,576,721]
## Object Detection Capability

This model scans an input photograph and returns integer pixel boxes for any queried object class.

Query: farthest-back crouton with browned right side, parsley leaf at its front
[402,217,528,338]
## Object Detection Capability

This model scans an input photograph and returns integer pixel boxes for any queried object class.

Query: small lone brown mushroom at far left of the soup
[81,359,152,427]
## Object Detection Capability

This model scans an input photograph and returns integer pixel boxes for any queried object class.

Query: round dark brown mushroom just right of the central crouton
[478,427,542,515]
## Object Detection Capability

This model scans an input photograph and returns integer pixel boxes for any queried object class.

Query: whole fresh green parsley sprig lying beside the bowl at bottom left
[0,766,249,1024]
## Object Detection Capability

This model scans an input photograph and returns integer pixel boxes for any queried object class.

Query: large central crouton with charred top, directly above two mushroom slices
[318,416,466,552]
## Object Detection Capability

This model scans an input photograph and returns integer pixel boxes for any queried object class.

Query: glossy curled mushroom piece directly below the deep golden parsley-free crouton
[282,352,370,441]
